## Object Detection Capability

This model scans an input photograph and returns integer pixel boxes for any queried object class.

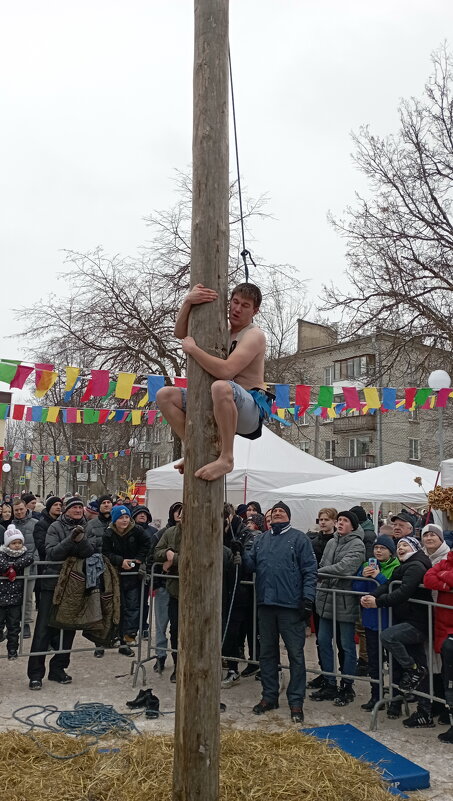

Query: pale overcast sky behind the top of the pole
[0,0,453,362]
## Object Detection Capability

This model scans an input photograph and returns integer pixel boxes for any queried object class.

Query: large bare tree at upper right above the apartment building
[323,46,453,376]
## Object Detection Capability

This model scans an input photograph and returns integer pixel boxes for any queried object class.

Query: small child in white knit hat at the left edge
[0,524,33,659]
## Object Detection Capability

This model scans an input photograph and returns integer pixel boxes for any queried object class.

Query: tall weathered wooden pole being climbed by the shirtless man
[173,0,229,801]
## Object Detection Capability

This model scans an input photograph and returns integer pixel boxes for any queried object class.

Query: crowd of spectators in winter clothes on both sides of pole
[0,493,453,743]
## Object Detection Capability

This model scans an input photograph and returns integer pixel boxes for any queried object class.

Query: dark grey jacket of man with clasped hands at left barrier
[42,515,97,590]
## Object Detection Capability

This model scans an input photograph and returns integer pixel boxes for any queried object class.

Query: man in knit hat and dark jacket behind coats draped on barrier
[27,496,96,690]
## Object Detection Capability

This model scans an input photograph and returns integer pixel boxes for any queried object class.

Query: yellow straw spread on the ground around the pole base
[0,730,418,801]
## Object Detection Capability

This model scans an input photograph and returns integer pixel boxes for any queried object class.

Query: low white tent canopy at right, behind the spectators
[257,462,437,530]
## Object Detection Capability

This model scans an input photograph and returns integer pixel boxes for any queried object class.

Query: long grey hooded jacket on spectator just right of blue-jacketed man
[316,529,365,623]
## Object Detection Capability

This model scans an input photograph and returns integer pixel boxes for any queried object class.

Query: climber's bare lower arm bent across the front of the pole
[182,328,266,381]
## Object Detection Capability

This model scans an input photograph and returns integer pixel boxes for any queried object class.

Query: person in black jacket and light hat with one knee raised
[360,537,434,728]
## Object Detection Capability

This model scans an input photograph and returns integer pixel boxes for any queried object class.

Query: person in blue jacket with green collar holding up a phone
[352,534,400,711]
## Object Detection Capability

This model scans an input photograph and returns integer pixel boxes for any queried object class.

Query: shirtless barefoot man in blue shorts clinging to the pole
[156,284,271,481]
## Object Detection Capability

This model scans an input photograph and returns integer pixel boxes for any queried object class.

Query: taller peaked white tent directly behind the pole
[146,426,342,523]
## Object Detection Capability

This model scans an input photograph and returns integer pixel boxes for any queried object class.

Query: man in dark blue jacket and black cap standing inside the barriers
[235,501,317,723]
